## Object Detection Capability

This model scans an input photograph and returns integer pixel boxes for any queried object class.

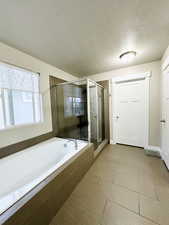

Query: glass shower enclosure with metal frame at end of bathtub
[50,79,105,149]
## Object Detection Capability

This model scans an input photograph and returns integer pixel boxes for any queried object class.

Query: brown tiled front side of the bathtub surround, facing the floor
[4,145,94,225]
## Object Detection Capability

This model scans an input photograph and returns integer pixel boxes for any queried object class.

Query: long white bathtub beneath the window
[0,138,88,218]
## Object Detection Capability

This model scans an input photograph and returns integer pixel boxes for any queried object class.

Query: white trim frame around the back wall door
[109,72,151,148]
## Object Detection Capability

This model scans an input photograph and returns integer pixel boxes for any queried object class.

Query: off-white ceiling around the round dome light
[0,0,169,76]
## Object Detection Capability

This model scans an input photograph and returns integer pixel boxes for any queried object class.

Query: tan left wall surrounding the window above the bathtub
[0,43,77,148]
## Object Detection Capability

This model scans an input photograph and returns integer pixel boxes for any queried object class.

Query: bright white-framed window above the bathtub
[0,63,42,129]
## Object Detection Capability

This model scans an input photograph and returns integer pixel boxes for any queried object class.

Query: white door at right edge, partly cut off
[161,71,169,168]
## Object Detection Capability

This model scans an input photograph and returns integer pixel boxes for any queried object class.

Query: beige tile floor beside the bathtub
[50,145,169,225]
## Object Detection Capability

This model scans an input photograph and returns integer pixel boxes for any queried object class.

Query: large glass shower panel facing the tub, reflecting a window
[51,83,88,140]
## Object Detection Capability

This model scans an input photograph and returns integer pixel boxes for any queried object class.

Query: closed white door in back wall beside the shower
[113,79,146,147]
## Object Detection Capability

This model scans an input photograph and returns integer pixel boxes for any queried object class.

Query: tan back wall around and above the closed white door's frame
[89,61,161,146]
